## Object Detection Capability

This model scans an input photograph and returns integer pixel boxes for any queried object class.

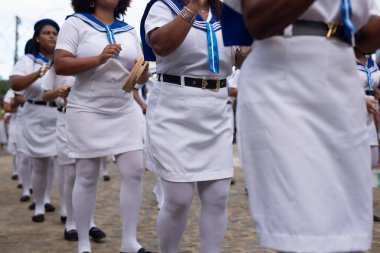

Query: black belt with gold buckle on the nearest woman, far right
[276,20,350,44]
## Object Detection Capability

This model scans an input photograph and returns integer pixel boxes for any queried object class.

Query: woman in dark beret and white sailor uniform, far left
[10,19,59,222]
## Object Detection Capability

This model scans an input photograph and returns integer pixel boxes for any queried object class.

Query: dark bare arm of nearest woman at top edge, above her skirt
[241,0,315,40]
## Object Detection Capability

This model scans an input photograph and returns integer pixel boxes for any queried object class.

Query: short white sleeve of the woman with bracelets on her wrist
[144,1,176,45]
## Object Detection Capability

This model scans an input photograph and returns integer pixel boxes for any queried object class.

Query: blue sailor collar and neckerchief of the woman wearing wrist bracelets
[140,0,221,73]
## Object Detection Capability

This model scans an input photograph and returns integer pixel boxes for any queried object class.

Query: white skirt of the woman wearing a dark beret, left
[17,102,58,158]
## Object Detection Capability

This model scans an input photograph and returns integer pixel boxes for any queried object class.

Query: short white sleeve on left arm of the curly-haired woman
[55,17,80,55]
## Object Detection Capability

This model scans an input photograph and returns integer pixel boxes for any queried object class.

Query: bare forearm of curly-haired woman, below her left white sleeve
[54,49,101,76]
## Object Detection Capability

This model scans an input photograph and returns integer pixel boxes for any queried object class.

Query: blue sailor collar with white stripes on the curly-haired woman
[66,13,134,34]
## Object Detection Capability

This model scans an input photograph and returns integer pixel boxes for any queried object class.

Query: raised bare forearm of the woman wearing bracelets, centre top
[149,4,199,57]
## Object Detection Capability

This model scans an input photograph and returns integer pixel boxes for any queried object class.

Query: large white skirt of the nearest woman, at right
[238,36,373,253]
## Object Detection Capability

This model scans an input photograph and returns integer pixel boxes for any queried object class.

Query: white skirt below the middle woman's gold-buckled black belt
[147,82,233,182]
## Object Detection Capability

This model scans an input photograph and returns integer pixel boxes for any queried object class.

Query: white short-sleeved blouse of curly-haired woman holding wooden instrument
[56,16,142,114]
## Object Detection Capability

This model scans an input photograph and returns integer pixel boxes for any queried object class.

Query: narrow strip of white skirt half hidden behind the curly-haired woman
[55,112,75,166]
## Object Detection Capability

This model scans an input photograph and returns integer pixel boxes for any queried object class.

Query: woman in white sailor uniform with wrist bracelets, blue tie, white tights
[141,0,246,253]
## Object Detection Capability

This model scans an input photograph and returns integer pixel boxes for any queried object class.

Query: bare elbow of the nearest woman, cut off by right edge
[356,16,380,53]
